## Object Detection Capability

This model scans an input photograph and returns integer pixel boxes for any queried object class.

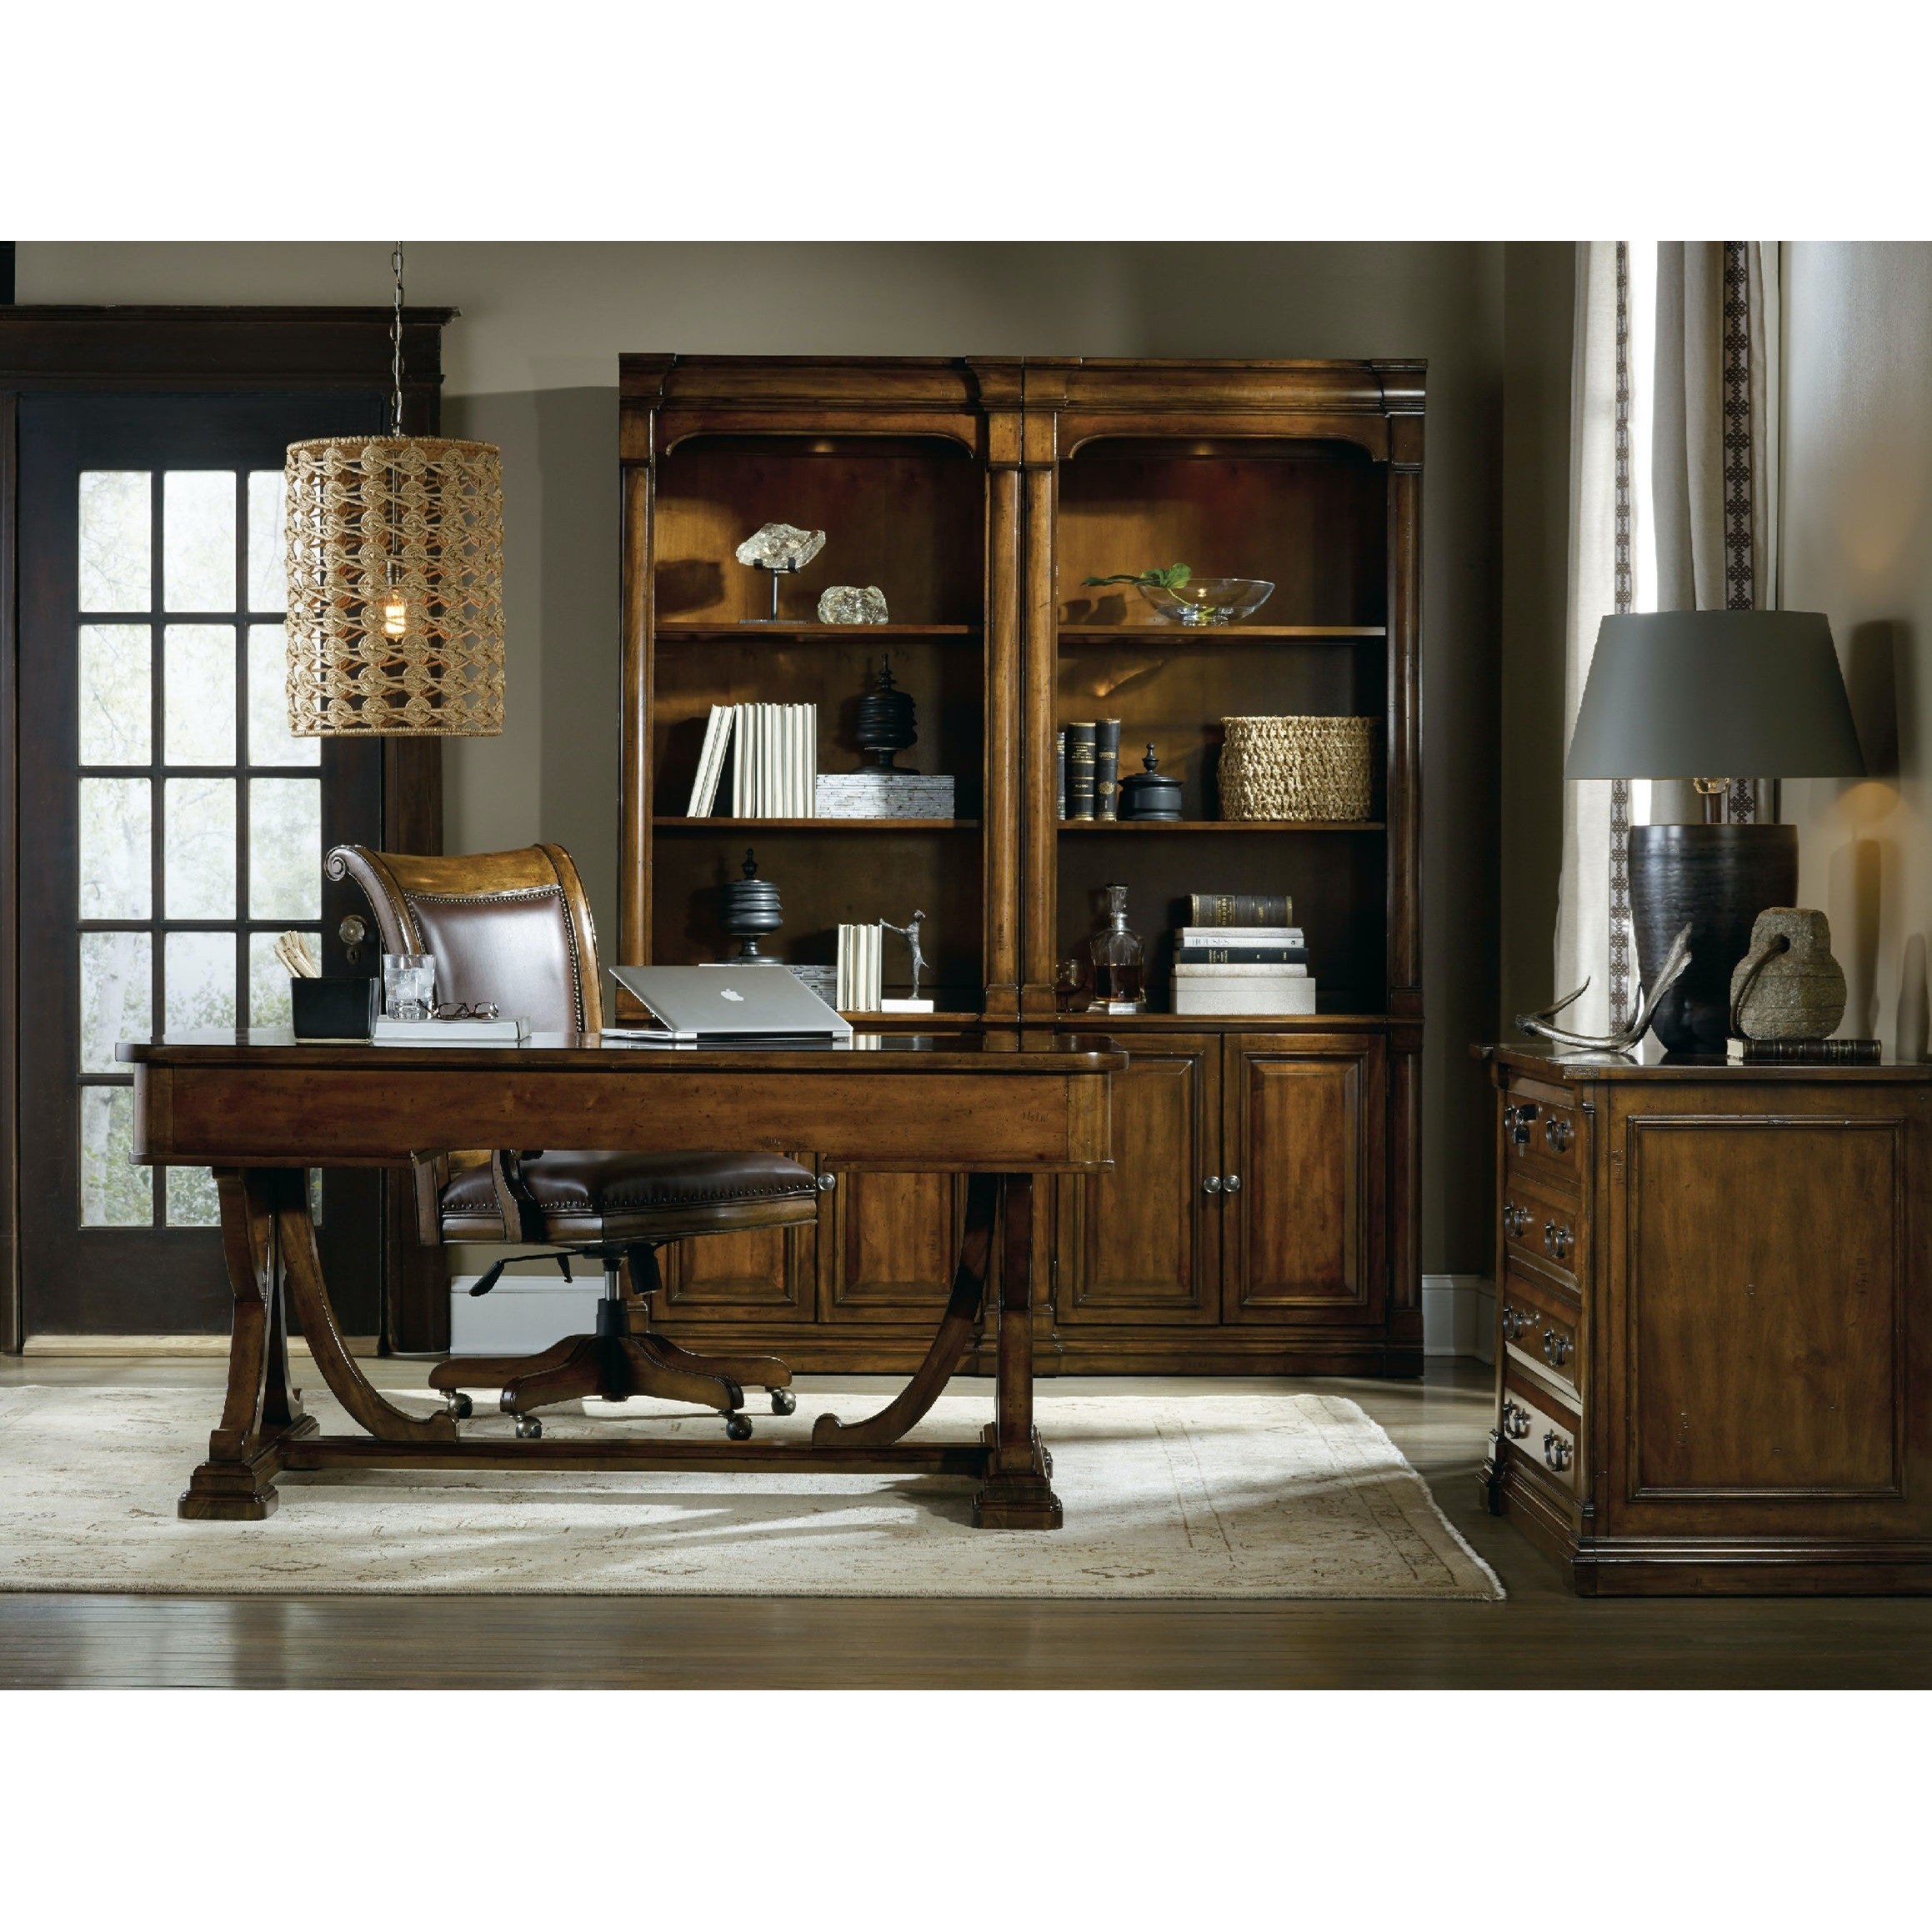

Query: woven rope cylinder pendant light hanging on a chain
[284,243,503,738]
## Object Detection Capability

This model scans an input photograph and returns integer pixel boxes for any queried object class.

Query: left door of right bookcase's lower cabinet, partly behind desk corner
[1055,1034,1221,1324]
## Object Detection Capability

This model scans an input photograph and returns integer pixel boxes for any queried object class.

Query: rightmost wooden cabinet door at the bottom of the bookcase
[1221,1034,1387,1322]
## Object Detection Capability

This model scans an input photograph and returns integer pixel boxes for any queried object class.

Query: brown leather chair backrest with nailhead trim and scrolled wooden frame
[324,844,603,1034]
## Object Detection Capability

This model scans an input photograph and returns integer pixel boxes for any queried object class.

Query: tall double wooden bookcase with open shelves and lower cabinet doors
[620,356,1424,1374]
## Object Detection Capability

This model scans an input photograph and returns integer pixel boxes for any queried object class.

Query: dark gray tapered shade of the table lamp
[1563,610,1864,778]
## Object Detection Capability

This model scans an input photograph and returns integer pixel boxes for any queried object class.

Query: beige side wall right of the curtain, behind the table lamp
[1781,242,1932,1059]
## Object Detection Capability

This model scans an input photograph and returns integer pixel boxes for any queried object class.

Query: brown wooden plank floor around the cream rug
[0,1356,1932,1689]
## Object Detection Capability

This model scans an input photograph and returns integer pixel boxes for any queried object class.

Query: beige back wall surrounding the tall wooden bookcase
[18,243,1503,1271]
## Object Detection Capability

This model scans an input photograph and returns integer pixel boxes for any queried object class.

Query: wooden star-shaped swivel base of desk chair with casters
[429,1300,798,1441]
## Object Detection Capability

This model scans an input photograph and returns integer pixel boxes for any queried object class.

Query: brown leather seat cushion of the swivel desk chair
[441,1149,819,1242]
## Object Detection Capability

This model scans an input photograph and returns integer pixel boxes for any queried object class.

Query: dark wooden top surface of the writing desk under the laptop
[114,1026,1126,1076]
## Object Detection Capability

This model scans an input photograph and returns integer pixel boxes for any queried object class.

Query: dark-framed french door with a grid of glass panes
[19,393,383,1335]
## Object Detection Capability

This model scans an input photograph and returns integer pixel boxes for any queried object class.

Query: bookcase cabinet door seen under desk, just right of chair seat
[821,1173,966,1322]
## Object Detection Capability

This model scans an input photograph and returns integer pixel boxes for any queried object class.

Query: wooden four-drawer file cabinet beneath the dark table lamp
[1482,1047,1932,1596]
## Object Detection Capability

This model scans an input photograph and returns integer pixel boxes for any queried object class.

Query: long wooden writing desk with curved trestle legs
[118,1028,1126,1530]
